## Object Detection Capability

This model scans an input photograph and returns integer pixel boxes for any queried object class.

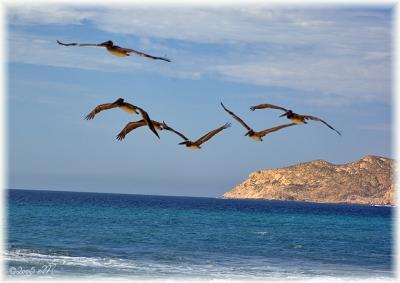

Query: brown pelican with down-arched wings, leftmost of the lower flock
[85,98,160,138]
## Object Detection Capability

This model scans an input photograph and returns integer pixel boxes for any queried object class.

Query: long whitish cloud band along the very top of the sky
[4,4,390,45]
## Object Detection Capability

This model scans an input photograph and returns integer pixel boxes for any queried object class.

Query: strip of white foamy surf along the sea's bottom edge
[3,249,390,282]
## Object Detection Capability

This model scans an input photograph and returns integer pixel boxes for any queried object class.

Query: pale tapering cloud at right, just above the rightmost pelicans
[215,52,391,101]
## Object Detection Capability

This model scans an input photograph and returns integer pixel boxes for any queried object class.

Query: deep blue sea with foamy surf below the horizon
[5,190,394,278]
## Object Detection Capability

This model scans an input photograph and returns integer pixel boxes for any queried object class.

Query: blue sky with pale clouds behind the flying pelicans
[7,4,393,196]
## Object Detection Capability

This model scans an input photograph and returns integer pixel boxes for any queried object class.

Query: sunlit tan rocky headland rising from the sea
[224,156,395,205]
